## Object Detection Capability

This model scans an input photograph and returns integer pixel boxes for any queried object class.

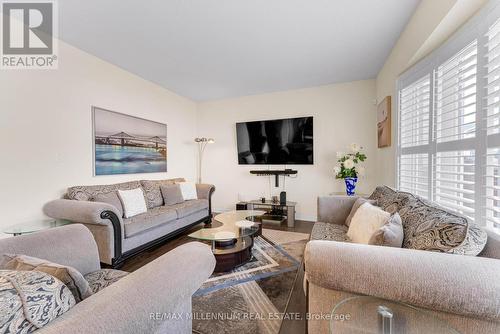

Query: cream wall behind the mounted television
[198,80,376,220]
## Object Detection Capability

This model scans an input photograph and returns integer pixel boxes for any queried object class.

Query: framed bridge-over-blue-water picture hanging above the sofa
[92,107,167,176]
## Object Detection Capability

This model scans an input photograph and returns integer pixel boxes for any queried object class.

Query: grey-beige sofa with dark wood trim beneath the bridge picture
[43,178,215,268]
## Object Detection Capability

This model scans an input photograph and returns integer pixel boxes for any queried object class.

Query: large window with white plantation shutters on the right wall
[397,2,500,233]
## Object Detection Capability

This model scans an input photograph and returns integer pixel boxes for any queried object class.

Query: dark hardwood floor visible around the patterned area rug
[121,215,313,334]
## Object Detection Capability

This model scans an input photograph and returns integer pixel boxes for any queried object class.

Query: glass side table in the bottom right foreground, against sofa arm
[330,296,460,334]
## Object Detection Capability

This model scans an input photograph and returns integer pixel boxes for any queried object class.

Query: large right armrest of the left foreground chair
[39,242,215,334]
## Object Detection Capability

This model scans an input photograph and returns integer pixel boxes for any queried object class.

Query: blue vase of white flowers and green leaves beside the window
[333,143,366,196]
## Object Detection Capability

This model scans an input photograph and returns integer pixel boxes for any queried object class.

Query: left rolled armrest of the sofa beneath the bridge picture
[43,199,122,225]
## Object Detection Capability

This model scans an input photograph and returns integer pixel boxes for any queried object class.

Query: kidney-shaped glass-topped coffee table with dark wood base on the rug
[189,210,266,272]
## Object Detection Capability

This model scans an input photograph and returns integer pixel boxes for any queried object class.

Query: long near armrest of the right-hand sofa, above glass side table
[305,241,500,321]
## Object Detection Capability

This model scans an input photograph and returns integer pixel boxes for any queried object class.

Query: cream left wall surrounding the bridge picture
[0,42,196,235]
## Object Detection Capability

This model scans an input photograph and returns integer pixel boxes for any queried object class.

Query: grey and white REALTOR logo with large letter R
[0,1,57,69]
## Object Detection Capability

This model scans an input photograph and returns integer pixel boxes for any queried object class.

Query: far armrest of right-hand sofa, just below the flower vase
[318,195,358,225]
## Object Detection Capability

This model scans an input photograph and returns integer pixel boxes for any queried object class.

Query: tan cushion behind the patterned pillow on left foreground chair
[3,254,92,303]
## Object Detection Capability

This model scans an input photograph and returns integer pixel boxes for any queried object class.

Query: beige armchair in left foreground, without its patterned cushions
[0,224,215,334]
